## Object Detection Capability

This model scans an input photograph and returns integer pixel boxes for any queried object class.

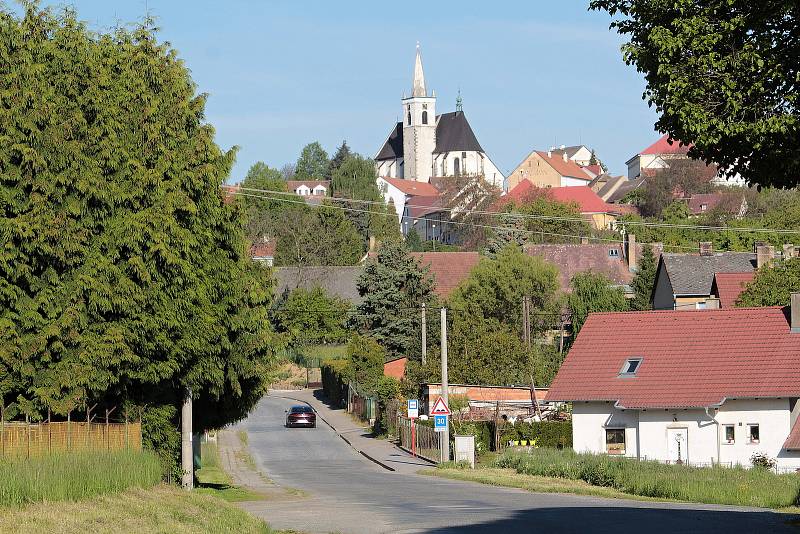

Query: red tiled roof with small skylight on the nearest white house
[547,306,800,409]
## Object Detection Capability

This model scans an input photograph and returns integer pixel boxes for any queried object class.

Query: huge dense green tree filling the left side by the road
[0,6,282,478]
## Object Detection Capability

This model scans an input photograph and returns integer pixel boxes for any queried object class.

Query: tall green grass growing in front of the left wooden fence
[0,451,161,508]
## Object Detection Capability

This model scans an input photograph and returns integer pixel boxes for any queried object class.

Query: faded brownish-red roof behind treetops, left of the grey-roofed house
[525,243,633,291]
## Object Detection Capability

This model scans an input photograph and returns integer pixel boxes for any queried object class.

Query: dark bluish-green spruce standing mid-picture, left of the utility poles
[354,240,433,356]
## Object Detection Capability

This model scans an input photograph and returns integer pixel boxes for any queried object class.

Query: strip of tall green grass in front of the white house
[494,449,800,508]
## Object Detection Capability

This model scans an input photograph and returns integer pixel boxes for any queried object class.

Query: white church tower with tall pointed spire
[402,43,436,182]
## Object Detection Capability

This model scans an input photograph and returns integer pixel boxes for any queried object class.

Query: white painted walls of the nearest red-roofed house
[572,399,800,468]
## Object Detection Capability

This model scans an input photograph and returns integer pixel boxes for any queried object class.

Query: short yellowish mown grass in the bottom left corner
[0,485,282,534]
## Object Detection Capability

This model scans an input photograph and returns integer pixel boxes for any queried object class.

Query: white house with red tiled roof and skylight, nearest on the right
[547,300,800,470]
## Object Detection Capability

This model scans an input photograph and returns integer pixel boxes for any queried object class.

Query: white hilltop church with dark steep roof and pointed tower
[375,45,505,188]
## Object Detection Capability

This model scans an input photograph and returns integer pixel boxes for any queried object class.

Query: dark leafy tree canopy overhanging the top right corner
[590,0,800,187]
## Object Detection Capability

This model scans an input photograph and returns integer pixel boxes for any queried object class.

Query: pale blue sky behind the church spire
[31,0,658,182]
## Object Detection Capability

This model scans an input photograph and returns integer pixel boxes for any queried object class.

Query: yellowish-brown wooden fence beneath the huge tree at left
[0,421,142,458]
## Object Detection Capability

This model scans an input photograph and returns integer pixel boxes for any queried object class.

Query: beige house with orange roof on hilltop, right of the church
[506,150,596,191]
